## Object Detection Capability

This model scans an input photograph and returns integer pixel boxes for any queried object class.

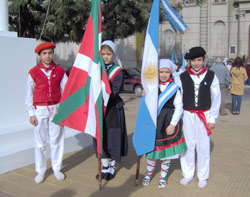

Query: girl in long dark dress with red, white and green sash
[95,40,128,180]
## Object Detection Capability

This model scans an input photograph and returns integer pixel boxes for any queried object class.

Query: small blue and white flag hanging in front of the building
[162,0,188,33]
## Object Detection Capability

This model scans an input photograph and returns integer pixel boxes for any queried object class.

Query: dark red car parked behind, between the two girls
[123,68,142,94]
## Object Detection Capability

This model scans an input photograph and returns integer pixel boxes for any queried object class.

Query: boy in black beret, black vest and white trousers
[180,47,221,188]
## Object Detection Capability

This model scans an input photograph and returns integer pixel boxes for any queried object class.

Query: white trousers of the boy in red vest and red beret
[34,105,64,173]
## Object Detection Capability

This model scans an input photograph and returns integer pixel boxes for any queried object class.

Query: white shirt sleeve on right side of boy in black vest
[207,75,221,124]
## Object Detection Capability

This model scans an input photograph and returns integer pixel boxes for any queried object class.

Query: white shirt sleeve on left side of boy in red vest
[25,74,35,116]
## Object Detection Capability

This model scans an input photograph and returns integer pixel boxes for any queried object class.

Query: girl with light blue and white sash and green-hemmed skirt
[142,59,187,188]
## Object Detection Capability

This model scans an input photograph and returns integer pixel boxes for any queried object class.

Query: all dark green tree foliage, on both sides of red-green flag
[9,0,152,42]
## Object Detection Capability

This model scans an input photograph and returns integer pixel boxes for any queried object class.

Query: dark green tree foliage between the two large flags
[103,0,152,40]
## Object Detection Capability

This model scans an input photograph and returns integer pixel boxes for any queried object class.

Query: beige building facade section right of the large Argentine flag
[160,0,250,62]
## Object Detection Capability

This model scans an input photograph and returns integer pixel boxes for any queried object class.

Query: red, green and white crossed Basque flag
[53,0,111,153]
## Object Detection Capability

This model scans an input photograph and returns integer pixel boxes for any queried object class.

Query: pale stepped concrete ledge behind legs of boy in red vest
[0,128,92,174]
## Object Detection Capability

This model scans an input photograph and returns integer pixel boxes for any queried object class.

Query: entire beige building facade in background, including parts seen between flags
[56,0,250,68]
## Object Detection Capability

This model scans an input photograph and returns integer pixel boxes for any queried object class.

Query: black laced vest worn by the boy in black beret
[180,70,214,110]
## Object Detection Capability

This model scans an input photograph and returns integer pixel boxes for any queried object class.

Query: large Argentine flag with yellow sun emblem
[133,0,160,156]
